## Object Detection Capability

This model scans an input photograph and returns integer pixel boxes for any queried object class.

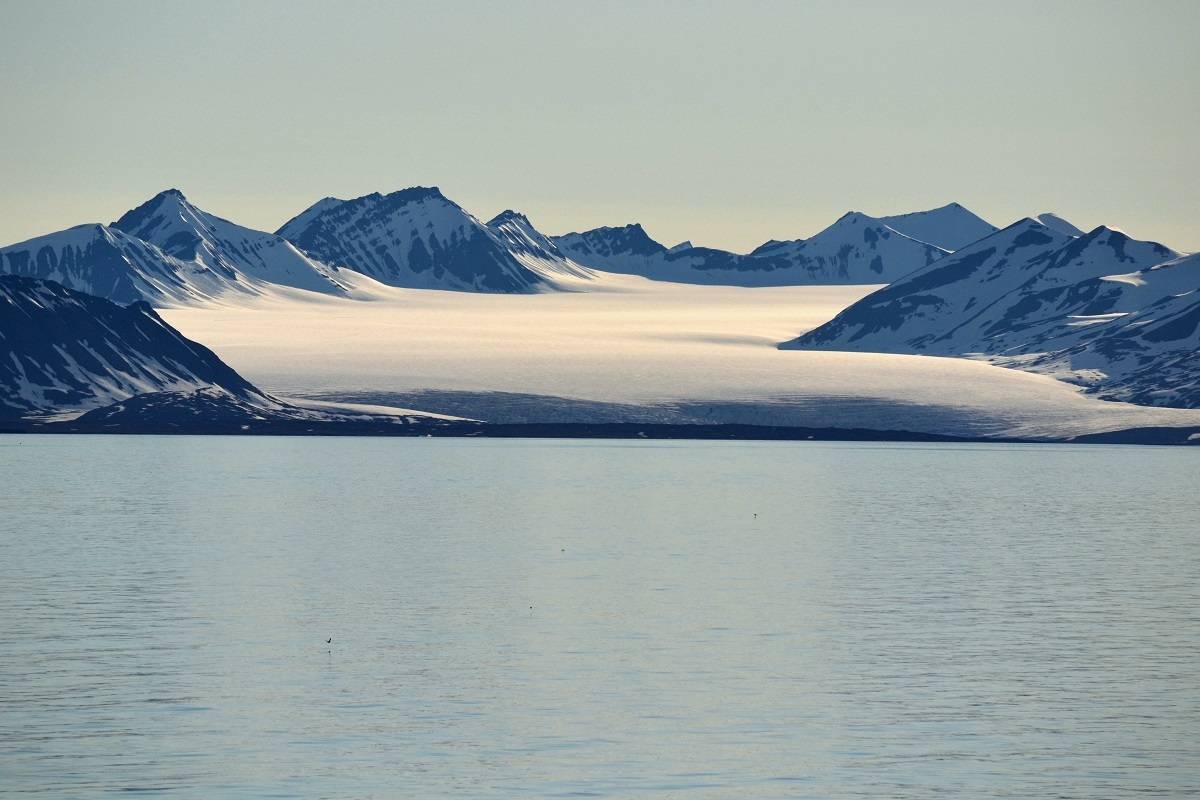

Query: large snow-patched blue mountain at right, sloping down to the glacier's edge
[780,218,1200,405]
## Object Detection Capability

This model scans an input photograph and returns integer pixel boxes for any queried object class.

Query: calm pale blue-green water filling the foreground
[0,437,1200,798]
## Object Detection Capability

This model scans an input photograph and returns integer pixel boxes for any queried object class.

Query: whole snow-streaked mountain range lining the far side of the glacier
[0,187,1027,306]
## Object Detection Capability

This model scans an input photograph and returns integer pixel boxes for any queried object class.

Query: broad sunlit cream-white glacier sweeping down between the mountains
[161,273,1200,438]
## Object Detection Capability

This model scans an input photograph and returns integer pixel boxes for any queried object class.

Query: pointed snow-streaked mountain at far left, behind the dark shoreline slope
[0,190,346,306]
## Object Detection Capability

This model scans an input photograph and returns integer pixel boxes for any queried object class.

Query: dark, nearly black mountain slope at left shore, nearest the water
[0,275,266,417]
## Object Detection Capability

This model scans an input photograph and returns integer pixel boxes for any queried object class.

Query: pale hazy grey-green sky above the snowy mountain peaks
[0,0,1200,251]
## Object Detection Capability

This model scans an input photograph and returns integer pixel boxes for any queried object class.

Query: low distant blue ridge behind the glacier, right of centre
[553,203,996,287]
